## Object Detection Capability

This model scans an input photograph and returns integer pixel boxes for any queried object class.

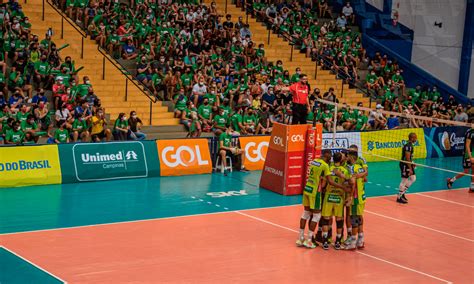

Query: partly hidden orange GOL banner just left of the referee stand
[239,136,270,171]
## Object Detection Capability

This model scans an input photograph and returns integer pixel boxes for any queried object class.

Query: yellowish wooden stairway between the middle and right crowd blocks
[205,0,370,107]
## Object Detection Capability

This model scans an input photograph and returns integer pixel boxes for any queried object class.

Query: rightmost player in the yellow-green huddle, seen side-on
[345,151,366,250]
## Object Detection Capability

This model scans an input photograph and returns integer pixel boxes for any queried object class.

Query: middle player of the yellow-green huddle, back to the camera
[320,153,351,250]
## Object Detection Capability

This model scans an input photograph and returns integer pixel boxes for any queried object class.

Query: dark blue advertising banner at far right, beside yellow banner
[424,126,469,158]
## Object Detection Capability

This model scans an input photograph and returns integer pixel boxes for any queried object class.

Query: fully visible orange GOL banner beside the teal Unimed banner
[156,139,212,176]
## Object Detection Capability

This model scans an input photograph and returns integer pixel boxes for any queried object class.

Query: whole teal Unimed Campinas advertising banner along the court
[59,141,159,183]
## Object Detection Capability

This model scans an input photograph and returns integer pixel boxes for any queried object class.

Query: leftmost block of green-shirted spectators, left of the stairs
[0,1,144,144]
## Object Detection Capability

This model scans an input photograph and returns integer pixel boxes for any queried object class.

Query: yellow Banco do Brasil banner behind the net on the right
[360,128,426,162]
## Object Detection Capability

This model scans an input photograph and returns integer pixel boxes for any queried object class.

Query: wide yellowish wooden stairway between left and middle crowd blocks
[22,0,182,125]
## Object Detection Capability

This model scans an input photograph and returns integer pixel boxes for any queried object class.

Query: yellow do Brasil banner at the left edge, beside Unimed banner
[0,145,61,187]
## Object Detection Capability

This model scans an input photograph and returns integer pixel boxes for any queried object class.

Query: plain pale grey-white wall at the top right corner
[392,0,466,89]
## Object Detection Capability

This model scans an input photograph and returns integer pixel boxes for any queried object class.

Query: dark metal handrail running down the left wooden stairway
[39,0,158,125]
